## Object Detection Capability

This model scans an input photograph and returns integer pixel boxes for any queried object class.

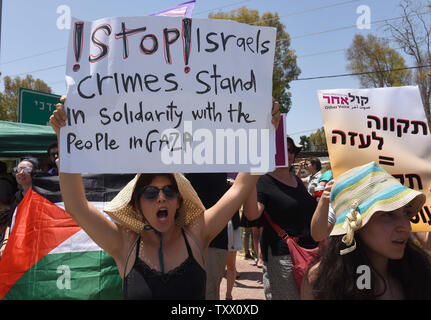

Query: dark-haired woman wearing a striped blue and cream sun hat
[301,162,431,299]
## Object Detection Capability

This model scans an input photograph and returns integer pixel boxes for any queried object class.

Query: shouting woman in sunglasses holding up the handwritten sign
[50,97,280,300]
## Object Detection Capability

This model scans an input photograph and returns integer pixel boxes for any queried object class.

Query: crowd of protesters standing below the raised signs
[0,98,431,300]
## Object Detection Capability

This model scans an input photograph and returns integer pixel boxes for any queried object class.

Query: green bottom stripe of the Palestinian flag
[5,251,123,300]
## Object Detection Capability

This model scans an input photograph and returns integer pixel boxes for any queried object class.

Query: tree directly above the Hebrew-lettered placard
[346,34,412,88]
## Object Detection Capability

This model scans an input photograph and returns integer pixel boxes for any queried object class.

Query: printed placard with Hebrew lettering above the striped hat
[318,86,431,231]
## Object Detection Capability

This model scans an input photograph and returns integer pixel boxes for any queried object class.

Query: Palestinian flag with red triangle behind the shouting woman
[0,175,133,300]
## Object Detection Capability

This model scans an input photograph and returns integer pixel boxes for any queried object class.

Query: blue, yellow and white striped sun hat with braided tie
[331,162,426,255]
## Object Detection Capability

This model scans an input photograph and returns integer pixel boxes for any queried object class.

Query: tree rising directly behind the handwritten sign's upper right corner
[208,7,301,113]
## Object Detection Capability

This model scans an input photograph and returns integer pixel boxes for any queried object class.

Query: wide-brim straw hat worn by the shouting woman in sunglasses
[104,173,205,233]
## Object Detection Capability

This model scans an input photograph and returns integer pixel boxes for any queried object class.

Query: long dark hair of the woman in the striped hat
[312,235,431,300]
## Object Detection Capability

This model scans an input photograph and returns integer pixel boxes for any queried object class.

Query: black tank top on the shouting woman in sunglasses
[123,229,206,300]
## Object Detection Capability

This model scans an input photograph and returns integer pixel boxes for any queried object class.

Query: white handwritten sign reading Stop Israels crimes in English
[60,17,276,173]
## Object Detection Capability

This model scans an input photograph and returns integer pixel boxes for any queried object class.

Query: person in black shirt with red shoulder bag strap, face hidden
[244,137,317,300]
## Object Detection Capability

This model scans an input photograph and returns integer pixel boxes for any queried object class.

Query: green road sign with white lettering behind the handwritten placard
[18,88,61,125]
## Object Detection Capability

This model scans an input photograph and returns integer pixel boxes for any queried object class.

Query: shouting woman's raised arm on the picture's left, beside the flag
[49,96,125,260]
